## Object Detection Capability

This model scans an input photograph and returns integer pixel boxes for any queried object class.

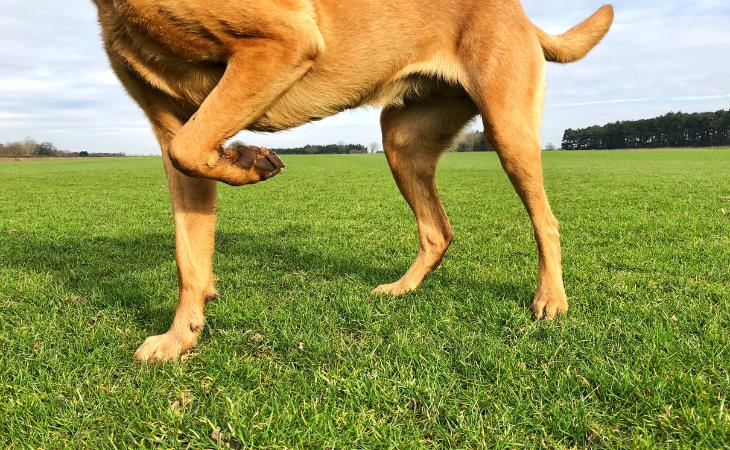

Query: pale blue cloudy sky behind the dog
[0,0,730,154]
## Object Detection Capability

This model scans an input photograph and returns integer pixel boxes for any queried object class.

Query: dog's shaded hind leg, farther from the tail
[373,89,476,295]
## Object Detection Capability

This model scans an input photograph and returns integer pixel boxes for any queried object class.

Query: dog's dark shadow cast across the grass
[0,230,531,331]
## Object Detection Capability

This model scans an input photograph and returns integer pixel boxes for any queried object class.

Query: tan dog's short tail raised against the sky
[535,5,613,63]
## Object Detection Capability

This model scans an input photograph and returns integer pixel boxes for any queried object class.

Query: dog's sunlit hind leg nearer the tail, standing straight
[465,29,568,319]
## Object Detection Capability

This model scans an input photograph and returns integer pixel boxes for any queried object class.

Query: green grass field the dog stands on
[0,150,730,448]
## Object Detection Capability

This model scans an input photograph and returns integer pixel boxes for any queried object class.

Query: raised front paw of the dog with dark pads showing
[221,145,284,186]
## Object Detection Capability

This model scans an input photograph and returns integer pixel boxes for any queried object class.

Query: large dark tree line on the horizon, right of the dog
[563,110,730,150]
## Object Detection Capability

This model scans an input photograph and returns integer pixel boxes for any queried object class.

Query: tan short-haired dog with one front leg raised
[94,0,613,361]
